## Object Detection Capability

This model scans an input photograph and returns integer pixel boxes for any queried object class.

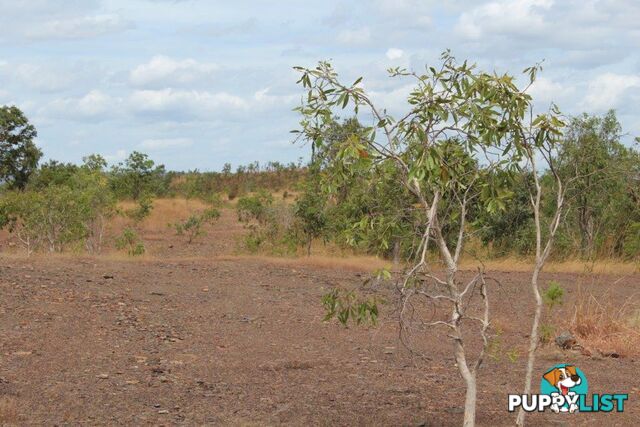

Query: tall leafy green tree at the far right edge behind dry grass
[558,110,640,258]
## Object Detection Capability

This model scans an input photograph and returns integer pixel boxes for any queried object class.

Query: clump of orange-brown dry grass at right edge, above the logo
[570,292,640,357]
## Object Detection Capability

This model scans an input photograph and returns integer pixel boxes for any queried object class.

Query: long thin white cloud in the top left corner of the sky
[25,14,133,40]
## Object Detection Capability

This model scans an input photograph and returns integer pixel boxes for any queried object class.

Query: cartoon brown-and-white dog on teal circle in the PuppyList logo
[540,365,587,413]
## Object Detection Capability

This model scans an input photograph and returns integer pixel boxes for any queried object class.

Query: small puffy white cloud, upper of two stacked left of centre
[129,55,219,86]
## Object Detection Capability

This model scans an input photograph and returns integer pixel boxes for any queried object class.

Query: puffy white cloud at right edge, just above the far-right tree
[582,73,640,111]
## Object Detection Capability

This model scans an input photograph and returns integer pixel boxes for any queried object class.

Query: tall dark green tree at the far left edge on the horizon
[0,106,42,190]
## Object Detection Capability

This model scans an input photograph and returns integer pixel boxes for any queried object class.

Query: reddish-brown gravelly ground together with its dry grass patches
[0,199,640,426]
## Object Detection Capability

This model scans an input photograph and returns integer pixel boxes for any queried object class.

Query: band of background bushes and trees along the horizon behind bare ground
[0,107,640,259]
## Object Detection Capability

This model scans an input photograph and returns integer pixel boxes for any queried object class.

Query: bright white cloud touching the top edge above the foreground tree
[455,0,554,40]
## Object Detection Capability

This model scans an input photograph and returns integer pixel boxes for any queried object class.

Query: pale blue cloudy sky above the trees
[0,0,640,171]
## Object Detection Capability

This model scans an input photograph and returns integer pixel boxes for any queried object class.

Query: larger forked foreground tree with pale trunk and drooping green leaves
[295,51,562,426]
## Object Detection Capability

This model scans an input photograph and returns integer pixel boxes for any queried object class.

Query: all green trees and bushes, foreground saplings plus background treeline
[0,52,640,426]
